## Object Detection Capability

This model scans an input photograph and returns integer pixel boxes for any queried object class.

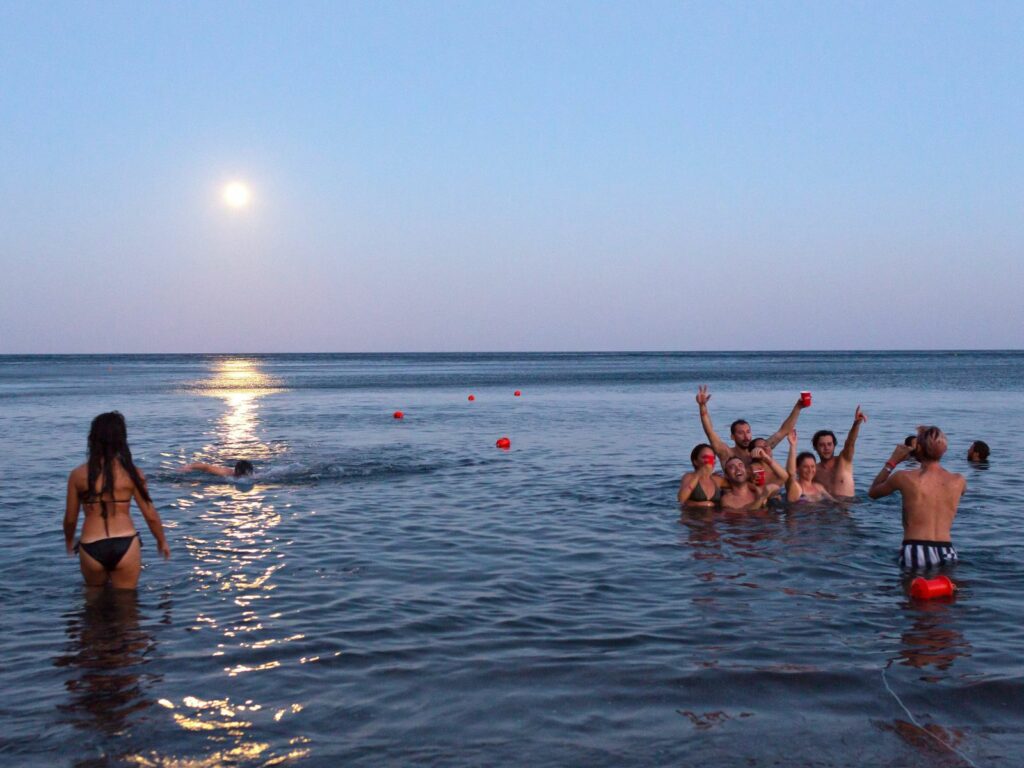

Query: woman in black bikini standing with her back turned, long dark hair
[63,411,171,589]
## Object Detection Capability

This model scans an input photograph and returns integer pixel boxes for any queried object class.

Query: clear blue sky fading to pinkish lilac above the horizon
[0,0,1024,353]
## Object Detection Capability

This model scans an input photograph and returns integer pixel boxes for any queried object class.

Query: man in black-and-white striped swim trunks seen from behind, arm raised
[867,427,967,569]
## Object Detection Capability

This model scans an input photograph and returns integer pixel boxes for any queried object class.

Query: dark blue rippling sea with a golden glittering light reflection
[0,352,1024,767]
